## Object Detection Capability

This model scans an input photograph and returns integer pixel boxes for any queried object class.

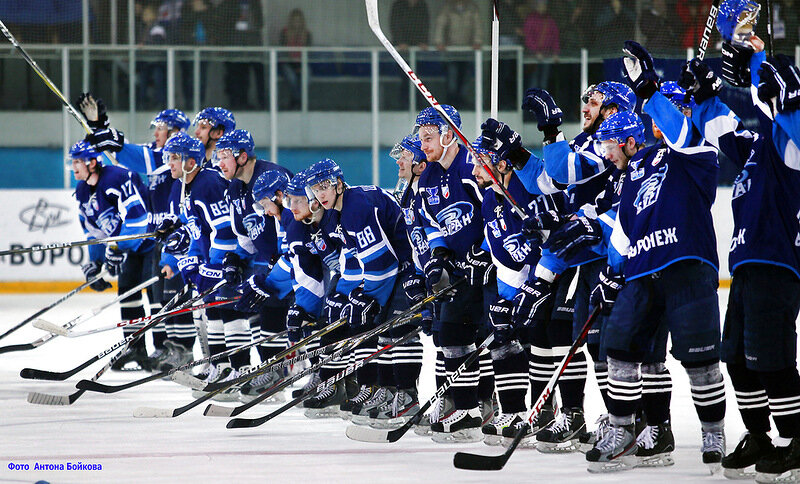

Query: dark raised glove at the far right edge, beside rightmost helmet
[758,54,800,113]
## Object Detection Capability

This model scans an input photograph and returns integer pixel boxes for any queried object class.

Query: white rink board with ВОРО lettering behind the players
[0,187,733,282]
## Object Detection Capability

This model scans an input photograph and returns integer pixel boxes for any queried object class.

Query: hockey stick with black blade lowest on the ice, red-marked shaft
[453,306,600,471]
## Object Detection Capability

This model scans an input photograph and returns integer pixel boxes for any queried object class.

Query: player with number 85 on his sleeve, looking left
[158,133,245,401]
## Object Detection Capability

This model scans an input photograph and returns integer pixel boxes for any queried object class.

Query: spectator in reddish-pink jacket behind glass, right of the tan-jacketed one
[523,0,561,89]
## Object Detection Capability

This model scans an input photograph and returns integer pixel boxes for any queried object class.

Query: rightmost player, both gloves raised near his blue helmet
[681,18,800,482]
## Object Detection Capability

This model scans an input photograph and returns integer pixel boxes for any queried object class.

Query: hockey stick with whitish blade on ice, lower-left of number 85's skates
[133,279,464,418]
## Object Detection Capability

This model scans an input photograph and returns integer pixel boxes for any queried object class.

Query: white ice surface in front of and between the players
[0,290,764,484]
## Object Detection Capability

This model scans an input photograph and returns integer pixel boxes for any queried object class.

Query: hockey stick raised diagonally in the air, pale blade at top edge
[364,0,528,220]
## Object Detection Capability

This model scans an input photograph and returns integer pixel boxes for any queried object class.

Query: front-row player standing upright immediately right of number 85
[215,129,291,398]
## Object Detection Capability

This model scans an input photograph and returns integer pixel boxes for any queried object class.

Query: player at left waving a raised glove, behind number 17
[78,93,195,371]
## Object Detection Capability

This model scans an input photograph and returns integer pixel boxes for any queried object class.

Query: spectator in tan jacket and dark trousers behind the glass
[433,0,486,106]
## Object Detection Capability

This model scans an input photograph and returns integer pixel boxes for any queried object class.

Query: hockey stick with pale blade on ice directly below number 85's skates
[203,315,417,417]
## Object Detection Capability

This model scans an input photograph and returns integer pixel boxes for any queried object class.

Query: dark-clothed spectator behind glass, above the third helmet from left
[216,0,267,110]
